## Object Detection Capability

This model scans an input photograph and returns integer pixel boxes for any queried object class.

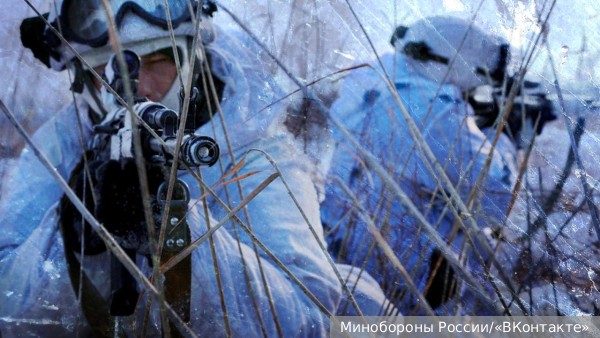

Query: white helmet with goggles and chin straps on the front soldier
[21,0,216,112]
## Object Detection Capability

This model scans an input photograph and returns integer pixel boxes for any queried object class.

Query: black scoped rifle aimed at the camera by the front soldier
[61,50,220,332]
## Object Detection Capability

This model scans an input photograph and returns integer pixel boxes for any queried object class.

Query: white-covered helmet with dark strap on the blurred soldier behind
[392,16,509,90]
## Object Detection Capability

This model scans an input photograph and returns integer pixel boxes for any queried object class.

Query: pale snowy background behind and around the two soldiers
[0,0,600,322]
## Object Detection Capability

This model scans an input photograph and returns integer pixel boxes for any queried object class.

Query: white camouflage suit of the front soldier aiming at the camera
[0,20,383,337]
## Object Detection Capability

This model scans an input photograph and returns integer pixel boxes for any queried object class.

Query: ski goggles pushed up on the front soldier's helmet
[59,0,198,48]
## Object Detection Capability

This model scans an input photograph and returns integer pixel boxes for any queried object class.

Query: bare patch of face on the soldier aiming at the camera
[94,53,177,102]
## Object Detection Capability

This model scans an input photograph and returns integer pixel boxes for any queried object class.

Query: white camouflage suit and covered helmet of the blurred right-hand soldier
[321,17,515,315]
